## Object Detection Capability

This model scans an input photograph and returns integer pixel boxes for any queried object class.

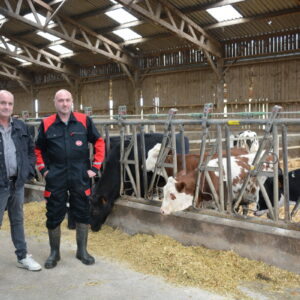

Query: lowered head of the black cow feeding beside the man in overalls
[90,195,112,231]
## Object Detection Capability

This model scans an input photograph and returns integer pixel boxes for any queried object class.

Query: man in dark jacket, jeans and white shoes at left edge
[0,90,41,271]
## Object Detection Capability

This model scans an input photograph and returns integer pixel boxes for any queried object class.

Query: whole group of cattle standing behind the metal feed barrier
[91,130,300,231]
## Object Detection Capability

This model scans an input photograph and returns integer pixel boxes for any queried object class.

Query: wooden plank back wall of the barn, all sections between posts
[6,59,300,114]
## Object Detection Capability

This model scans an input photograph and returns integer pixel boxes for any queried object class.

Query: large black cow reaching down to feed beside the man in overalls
[91,133,189,231]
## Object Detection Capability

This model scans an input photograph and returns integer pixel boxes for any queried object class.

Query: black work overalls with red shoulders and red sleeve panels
[35,112,105,229]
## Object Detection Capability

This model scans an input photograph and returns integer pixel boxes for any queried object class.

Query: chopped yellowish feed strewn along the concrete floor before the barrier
[3,202,300,299]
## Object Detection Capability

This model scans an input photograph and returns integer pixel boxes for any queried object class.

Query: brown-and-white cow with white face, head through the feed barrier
[161,149,273,215]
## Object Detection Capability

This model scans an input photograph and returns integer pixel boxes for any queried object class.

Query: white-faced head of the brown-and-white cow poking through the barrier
[160,172,195,215]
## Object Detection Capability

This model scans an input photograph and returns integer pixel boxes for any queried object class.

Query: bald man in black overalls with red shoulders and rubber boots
[35,90,105,269]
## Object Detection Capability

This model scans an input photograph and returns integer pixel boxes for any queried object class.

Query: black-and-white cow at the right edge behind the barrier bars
[254,169,300,216]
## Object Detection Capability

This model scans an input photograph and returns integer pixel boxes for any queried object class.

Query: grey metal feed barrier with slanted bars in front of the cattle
[29,108,300,230]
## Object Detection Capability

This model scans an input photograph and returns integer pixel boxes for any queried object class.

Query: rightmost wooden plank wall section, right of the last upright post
[225,59,300,111]
